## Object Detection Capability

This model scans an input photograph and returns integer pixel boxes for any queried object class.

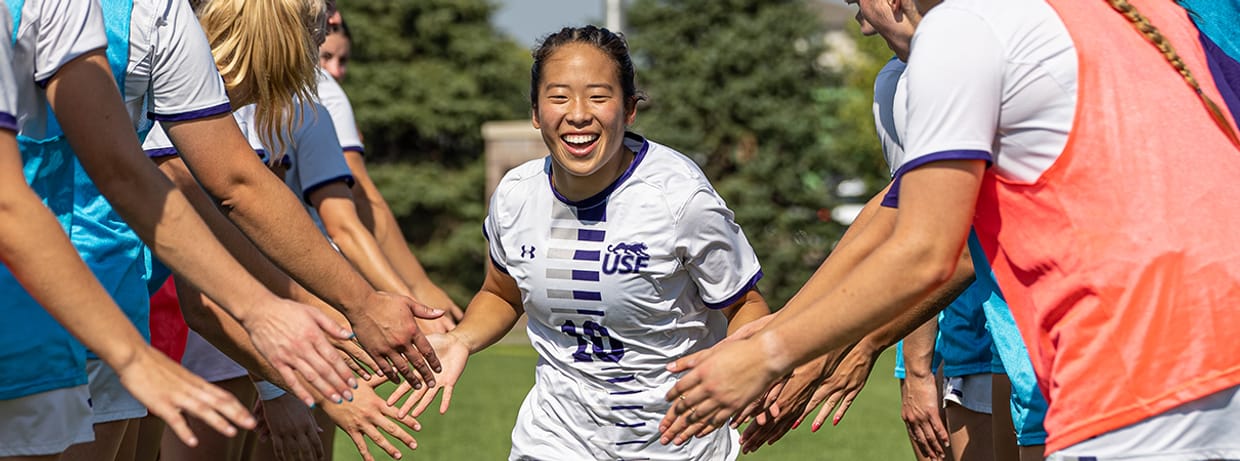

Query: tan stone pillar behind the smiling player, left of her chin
[482,120,547,202]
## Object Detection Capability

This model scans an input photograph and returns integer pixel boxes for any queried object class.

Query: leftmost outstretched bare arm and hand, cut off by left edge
[0,129,254,446]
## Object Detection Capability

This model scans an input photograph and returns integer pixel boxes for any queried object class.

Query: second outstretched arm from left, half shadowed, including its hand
[47,50,352,403]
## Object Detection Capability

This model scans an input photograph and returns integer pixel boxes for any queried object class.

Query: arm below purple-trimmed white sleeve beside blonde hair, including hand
[164,116,441,387]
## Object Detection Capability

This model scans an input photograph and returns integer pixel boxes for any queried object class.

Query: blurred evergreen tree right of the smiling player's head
[627,0,890,307]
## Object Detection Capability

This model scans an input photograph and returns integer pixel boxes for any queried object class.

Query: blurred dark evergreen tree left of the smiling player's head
[340,0,531,302]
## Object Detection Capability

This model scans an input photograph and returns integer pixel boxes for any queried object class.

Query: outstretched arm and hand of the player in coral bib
[665,160,985,441]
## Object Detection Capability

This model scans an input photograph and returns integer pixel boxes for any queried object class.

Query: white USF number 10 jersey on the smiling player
[484,135,761,460]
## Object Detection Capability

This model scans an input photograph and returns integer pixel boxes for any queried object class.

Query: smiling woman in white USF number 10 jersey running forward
[391,26,769,460]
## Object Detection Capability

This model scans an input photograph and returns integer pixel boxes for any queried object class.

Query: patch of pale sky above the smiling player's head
[491,0,605,48]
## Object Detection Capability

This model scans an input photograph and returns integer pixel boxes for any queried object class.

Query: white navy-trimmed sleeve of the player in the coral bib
[893,0,1076,205]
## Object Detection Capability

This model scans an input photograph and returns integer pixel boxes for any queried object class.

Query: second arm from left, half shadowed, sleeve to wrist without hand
[47,51,274,318]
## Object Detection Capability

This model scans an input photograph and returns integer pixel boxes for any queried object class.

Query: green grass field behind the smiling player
[334,345,911,461]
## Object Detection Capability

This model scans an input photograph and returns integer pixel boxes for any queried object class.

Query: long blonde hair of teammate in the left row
[198,0,327,165]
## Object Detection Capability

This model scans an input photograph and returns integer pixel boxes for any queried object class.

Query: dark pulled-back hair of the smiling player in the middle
[529,26,646,109]
